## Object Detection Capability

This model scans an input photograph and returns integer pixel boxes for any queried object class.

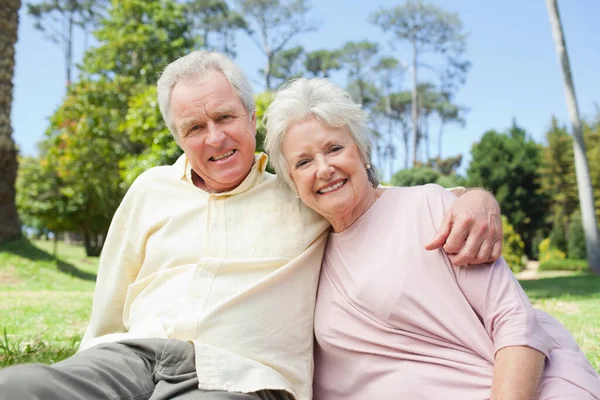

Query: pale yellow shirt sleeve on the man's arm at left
[79,183,141,351]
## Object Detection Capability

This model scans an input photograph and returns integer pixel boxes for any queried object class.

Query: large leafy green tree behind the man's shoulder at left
[34,0,193,255]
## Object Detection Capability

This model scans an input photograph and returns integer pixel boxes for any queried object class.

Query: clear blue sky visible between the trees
[12,0,600,177]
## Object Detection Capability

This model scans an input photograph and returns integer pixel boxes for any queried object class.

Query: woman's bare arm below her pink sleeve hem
[492,346,546,400]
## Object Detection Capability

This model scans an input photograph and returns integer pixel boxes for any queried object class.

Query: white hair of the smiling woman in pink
[264,78,379,191]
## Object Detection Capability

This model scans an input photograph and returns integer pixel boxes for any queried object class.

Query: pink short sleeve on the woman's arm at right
[429,187,552,356]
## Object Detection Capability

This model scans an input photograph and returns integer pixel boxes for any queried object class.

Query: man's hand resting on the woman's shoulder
[425,188,503,266]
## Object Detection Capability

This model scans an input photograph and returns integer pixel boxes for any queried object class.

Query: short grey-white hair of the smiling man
[157,51,255,145]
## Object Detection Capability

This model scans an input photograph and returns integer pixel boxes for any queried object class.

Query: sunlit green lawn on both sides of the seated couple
[0,240,600,371]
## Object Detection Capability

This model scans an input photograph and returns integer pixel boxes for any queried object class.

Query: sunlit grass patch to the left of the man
[0,240,98,367]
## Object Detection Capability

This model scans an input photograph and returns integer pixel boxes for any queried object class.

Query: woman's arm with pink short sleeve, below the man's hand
[431,190,552,400]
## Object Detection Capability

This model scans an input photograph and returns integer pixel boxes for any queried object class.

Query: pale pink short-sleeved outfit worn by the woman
[314,185,600,400]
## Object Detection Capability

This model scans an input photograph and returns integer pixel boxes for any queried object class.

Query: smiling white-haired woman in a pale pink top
[266,79,600,400]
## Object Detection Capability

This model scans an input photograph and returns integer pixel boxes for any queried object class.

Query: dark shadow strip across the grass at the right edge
[520,274,600,299]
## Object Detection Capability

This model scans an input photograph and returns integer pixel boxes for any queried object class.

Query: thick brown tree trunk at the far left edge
[0,0,21,243]
